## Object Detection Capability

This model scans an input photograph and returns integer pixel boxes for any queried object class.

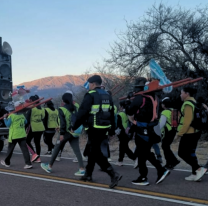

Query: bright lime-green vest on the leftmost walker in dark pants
[8,114,27,143]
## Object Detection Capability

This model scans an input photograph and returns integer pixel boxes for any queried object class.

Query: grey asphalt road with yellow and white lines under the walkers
[0,152,208,206]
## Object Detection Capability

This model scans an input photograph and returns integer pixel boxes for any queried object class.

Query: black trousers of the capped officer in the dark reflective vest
[86,128,111,176]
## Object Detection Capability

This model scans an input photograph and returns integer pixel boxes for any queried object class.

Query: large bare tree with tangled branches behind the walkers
[105,3,208,96]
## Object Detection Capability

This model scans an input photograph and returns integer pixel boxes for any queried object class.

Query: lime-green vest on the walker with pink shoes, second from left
[30,107,45,132]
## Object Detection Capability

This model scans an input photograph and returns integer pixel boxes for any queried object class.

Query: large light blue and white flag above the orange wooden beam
[149,59,173,93]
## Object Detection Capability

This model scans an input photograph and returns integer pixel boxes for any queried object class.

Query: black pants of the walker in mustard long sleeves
[178,132,201,174]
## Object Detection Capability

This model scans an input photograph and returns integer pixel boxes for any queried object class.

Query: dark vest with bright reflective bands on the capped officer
[88,90,112,129]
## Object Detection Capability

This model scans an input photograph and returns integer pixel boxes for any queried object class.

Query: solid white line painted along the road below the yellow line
[0,171,205,206]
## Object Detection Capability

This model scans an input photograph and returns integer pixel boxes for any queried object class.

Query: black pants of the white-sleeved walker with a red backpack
[162,130,178,165]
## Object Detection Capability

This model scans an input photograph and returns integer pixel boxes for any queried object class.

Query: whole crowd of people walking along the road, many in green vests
[1,75,208,188]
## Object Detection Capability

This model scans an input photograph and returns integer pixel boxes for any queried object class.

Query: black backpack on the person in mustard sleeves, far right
[188,100,208,131]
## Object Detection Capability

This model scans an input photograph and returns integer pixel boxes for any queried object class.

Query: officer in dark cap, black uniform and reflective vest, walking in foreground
[71,75,122,188]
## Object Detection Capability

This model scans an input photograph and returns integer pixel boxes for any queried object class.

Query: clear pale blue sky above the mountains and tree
[0,0,208,85]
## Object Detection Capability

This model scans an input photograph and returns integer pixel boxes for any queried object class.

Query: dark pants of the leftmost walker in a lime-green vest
[5,138,31,165]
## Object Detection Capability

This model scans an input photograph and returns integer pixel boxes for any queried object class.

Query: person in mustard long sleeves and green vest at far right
[175,86,207,182]
